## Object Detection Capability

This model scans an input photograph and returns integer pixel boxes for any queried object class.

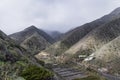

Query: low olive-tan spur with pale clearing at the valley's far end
[36,41,68,63]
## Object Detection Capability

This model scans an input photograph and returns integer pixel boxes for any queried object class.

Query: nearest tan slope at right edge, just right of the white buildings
[88,36,120,74]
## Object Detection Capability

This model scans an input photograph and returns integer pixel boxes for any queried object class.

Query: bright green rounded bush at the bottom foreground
[21,66,53,80]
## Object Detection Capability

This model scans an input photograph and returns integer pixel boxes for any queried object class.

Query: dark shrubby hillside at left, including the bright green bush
[0,28,53,80]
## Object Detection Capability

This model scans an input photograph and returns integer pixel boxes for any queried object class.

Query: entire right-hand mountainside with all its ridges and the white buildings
[36,8,120,75]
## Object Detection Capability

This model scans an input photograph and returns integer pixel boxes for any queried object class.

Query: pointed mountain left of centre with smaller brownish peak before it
[9,26,55,54]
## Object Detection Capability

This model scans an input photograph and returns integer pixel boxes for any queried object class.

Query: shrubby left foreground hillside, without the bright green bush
[0,31,40,80]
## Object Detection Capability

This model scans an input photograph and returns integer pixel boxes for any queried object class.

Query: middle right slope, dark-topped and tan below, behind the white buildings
[65,18,120,62]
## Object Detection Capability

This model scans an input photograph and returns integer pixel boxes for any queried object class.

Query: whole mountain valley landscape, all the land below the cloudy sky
[0,4,120,80]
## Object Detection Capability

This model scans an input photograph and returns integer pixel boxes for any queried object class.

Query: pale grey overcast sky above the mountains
[0,0,120,34]
